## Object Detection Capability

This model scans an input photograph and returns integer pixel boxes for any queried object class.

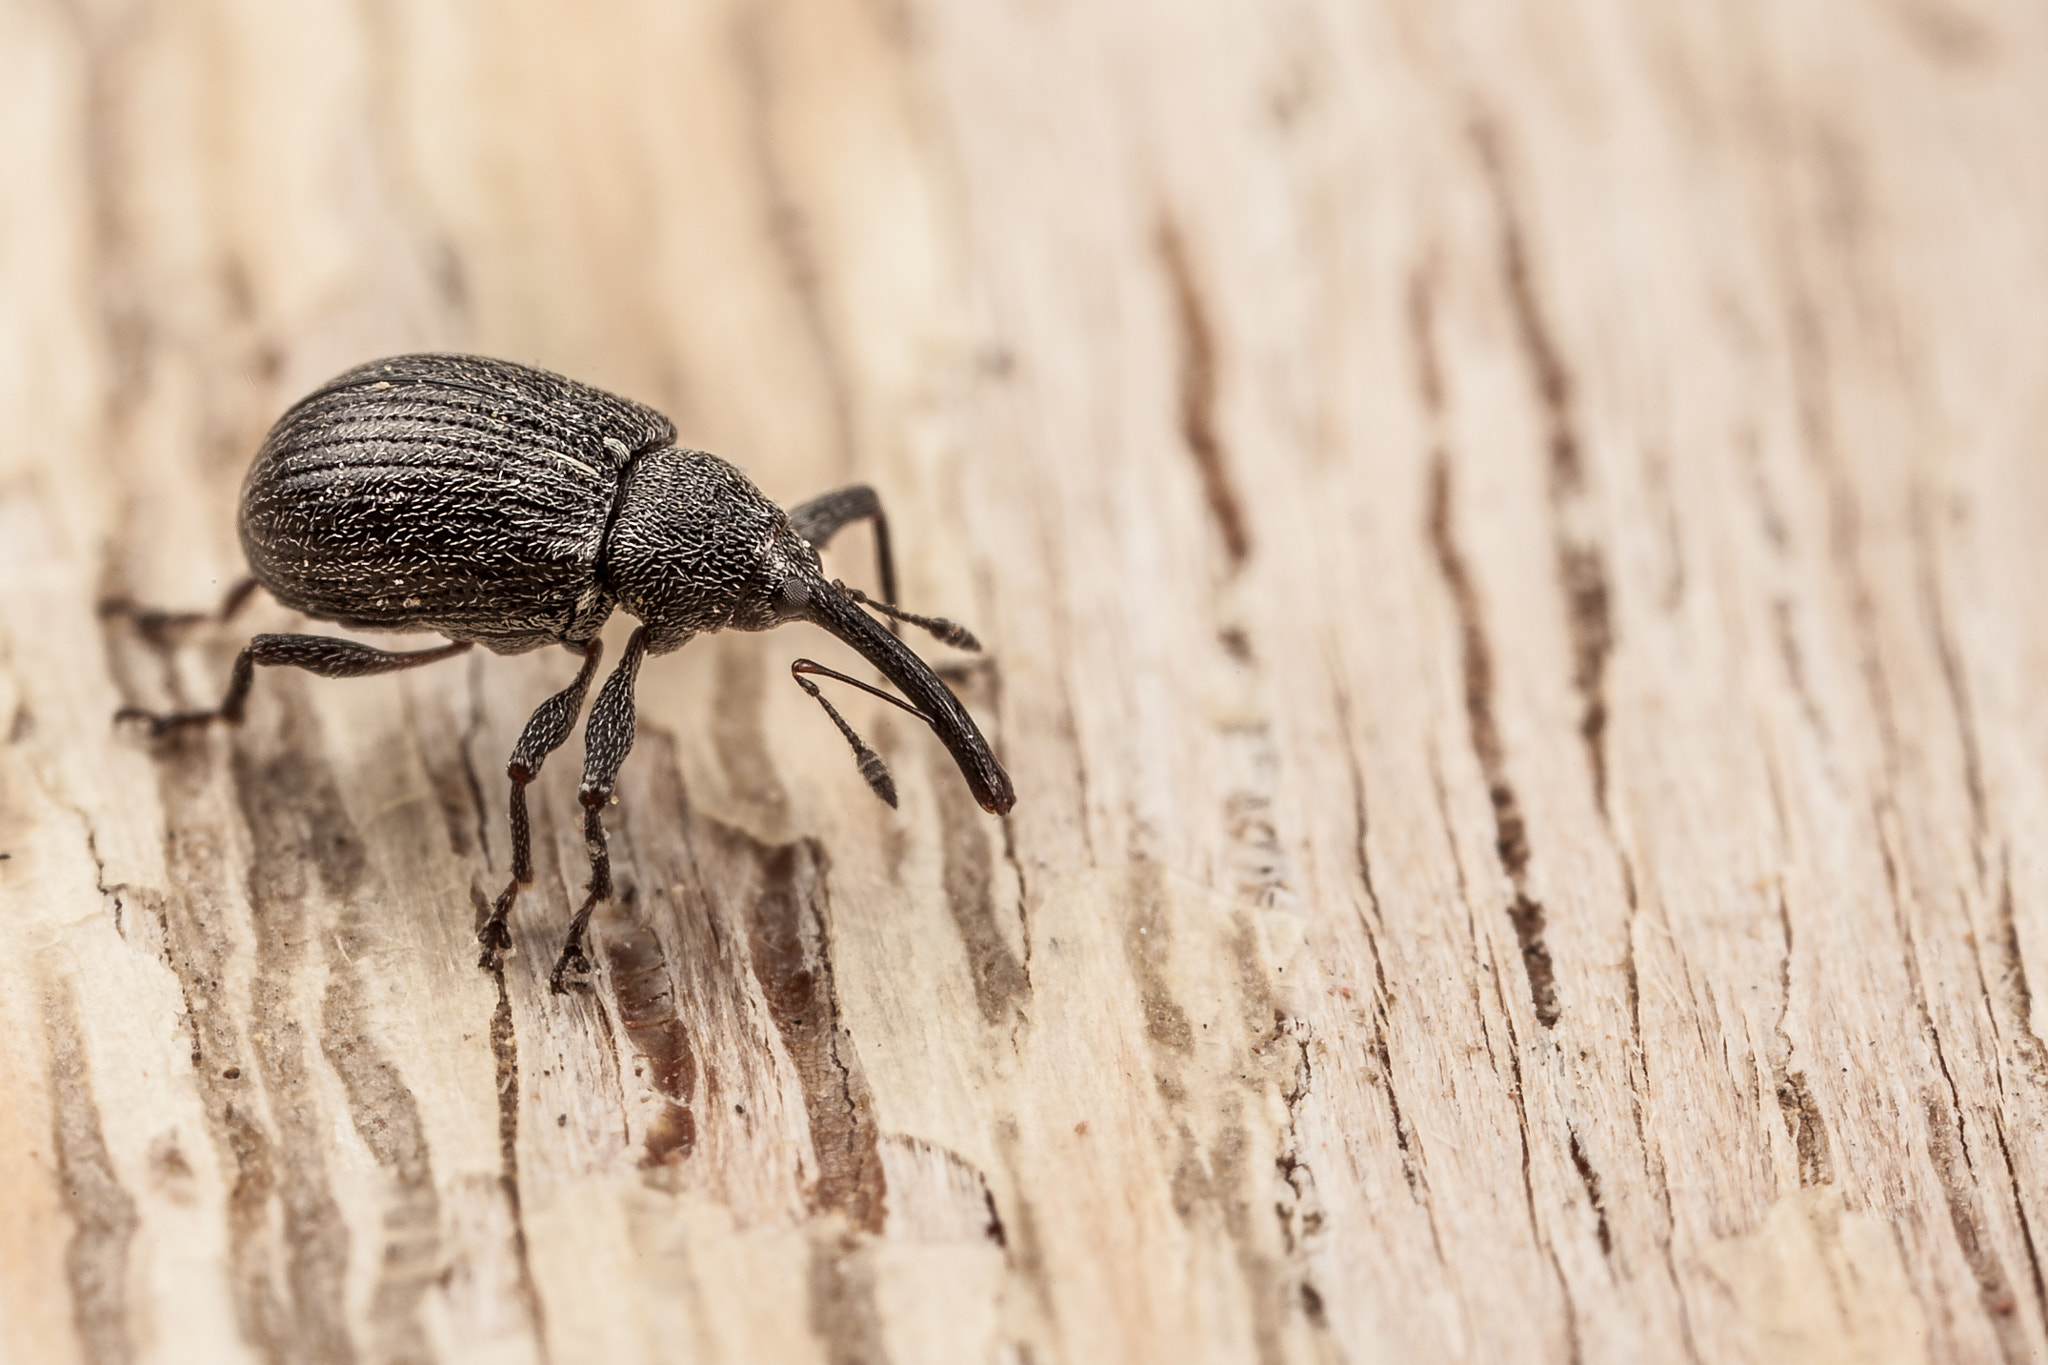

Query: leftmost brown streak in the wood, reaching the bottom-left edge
[43,978,141,1365]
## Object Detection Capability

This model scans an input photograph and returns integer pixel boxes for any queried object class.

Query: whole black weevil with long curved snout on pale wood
[117,356,1016,990]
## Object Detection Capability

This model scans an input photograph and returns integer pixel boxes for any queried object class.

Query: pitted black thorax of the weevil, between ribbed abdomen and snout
[600,446,819,653]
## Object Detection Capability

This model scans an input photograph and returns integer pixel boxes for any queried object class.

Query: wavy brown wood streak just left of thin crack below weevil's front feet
[319,933,444,1365]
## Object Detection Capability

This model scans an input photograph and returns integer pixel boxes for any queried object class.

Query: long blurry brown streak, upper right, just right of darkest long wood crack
[1473,115,1614,819]
